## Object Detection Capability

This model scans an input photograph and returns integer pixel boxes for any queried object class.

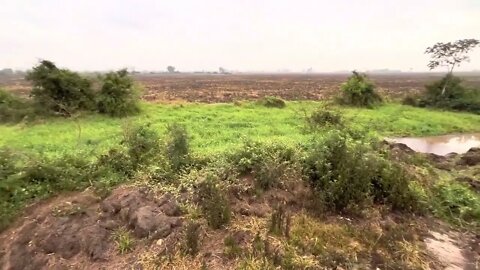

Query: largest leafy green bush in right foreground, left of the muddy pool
[303,130,417,211]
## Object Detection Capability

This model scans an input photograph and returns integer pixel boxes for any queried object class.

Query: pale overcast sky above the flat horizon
[0,0,480,72]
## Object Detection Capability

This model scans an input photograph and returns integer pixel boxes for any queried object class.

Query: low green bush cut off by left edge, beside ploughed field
[0,89,33,122]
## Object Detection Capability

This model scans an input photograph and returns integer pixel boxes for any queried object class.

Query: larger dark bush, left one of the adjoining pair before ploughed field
[26,60,95,116]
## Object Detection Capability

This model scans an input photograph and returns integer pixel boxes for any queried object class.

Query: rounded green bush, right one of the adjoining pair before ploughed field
[97,69,140,117]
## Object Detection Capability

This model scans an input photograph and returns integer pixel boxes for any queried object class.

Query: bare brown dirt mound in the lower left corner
[0,188,182,270]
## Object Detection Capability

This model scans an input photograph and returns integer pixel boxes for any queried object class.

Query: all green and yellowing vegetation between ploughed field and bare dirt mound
[0,98,480,269]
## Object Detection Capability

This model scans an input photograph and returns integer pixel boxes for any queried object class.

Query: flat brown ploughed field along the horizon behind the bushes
[0,73,480,103]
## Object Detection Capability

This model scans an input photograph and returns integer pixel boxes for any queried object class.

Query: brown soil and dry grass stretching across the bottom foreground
[0,144,480,270]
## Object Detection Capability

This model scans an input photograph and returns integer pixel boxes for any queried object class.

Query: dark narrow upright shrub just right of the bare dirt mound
[197,176,231,229]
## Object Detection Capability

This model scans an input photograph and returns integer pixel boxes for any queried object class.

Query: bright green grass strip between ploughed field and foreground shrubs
[0,101,480,156]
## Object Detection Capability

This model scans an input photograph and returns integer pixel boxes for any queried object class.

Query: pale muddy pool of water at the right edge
[392,133,480,155]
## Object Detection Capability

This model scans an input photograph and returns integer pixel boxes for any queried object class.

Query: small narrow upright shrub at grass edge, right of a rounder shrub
[166,124,190,170]
